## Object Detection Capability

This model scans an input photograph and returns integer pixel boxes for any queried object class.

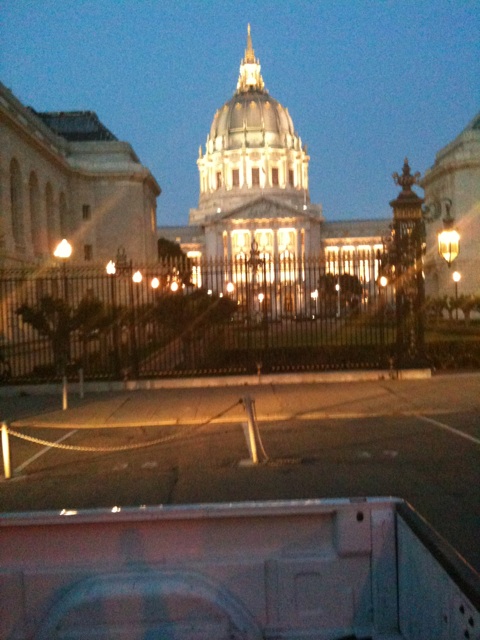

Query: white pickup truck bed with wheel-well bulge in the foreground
[0,499,480,640]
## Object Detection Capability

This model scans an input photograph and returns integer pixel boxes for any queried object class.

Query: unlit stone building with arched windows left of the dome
[0,83,160,267]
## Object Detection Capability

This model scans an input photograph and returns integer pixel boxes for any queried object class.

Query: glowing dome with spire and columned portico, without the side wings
[189,26,323,259]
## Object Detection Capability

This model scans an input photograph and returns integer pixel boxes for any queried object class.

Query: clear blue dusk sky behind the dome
[0,0,480,226]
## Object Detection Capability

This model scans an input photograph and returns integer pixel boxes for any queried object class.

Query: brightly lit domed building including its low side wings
[158,27,390,296]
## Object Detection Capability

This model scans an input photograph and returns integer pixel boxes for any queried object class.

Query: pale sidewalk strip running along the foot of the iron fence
[0,371,480,429]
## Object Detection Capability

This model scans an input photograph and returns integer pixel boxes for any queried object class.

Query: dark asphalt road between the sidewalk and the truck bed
[0,412,480,572]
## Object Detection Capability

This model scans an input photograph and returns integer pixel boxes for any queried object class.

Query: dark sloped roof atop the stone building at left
[30,107,117,142]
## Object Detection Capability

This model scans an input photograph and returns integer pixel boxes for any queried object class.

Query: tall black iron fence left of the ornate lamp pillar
[0,253,396,383]
